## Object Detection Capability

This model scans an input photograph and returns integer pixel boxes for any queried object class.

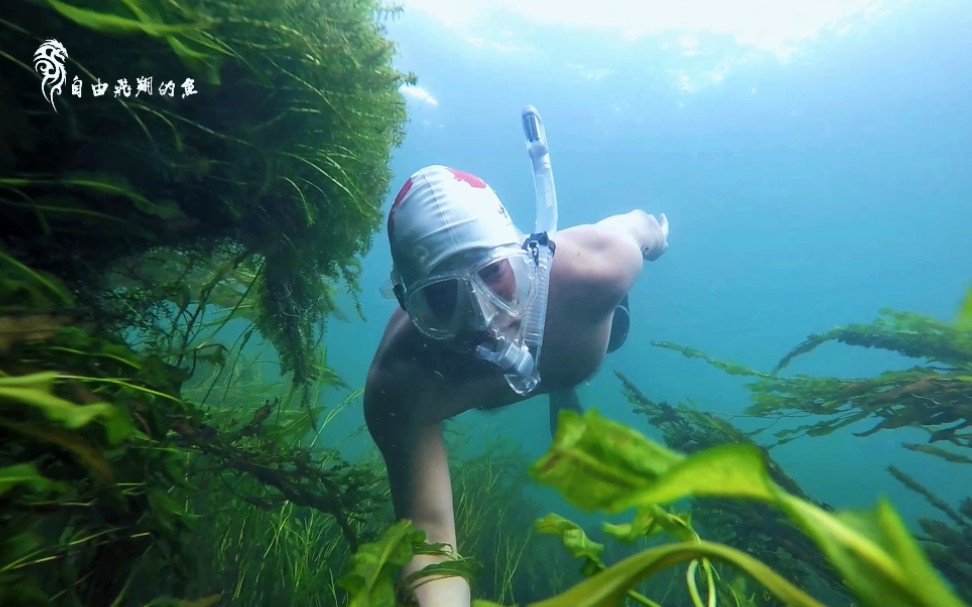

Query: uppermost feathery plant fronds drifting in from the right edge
[654,310,972,458]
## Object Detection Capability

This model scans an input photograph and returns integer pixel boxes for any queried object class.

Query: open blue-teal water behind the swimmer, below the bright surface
[328,0,972,540]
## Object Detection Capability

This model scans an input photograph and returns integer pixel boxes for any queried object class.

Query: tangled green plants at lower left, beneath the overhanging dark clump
[0,252,387,607]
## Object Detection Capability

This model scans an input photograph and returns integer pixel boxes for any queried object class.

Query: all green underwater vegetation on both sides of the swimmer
[0,0,972,607]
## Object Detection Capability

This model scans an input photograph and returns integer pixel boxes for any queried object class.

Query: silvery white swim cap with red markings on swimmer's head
[388,165,524,291]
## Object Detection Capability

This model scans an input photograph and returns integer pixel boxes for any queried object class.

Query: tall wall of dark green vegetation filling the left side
[0,0,411,607]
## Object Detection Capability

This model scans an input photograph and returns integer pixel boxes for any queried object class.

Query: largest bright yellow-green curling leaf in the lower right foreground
[533,412,962,606]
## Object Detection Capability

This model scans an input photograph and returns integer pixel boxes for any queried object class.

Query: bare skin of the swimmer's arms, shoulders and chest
[364,210,668,607]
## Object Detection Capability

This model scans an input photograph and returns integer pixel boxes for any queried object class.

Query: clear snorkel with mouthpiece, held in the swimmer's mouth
[476,105,557,395]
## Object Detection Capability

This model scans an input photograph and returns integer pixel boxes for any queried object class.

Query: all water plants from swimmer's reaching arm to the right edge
[340,310,972,607]
